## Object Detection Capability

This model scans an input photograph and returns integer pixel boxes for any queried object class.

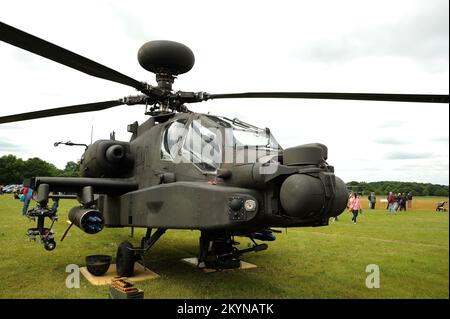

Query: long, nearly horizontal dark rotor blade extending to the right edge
[206,92,449,103]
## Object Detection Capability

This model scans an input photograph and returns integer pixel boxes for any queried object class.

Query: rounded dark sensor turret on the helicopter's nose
[280,174,348,218]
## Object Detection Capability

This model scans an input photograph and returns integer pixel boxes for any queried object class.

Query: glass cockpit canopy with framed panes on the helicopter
[161,114,281,173]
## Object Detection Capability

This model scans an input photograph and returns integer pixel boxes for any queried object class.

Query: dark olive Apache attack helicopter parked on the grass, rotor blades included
[0,22,449,276]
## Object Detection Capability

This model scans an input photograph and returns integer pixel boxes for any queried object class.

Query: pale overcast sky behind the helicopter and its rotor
[0,0,449,185]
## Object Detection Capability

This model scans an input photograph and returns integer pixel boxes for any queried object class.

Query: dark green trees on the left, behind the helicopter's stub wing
[0,155,80,185]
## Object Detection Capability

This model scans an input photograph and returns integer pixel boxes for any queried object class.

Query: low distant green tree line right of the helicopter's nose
[347,181,448,197]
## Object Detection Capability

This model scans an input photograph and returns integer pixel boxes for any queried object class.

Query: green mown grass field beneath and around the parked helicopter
[0,195,449,298]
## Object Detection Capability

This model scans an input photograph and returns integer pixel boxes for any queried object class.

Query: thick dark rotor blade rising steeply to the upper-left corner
[0,22,144,91]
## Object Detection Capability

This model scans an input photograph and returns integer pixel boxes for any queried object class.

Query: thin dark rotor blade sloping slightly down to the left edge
[0,100,124,124]
